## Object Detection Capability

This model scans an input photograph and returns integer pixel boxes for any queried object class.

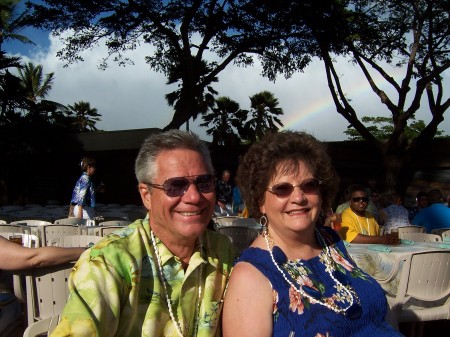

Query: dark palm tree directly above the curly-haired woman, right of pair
[243,91,283,143]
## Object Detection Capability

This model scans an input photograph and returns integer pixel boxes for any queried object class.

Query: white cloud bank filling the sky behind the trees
[17,32,450,141]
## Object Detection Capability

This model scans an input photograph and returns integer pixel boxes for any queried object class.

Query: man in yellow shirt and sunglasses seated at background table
[339,185,399,245]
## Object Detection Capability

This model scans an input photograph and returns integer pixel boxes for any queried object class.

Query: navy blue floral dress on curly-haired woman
[236,227,403,337]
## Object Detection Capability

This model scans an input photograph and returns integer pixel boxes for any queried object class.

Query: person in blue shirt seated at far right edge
[412,189,450,233]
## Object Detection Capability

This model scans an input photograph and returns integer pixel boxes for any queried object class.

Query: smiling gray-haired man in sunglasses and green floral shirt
[52,130,235,337]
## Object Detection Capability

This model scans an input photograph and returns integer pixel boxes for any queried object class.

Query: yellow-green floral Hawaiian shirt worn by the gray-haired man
[51,219,236,337]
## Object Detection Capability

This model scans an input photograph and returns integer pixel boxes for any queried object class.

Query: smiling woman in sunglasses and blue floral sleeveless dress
[223,131,401,337]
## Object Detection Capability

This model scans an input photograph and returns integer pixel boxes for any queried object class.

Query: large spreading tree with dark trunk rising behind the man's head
[23,0,309,129]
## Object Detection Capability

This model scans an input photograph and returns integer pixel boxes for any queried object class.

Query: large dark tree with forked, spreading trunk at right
[260,0,450,193]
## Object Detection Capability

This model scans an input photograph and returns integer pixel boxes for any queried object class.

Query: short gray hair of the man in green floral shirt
[134,129,214,183]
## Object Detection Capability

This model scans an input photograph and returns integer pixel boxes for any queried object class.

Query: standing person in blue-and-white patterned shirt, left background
[69,157,96,219]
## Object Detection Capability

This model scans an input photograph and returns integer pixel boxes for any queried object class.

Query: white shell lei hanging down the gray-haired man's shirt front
[150,229,203,337]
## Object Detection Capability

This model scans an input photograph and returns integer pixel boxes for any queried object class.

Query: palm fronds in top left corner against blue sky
[0,0,34,50]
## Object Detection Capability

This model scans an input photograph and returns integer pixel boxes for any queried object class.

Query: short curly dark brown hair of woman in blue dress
[237,131,339,218]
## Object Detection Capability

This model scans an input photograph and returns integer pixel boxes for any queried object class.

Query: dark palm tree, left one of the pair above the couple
[200,97,247,145]
